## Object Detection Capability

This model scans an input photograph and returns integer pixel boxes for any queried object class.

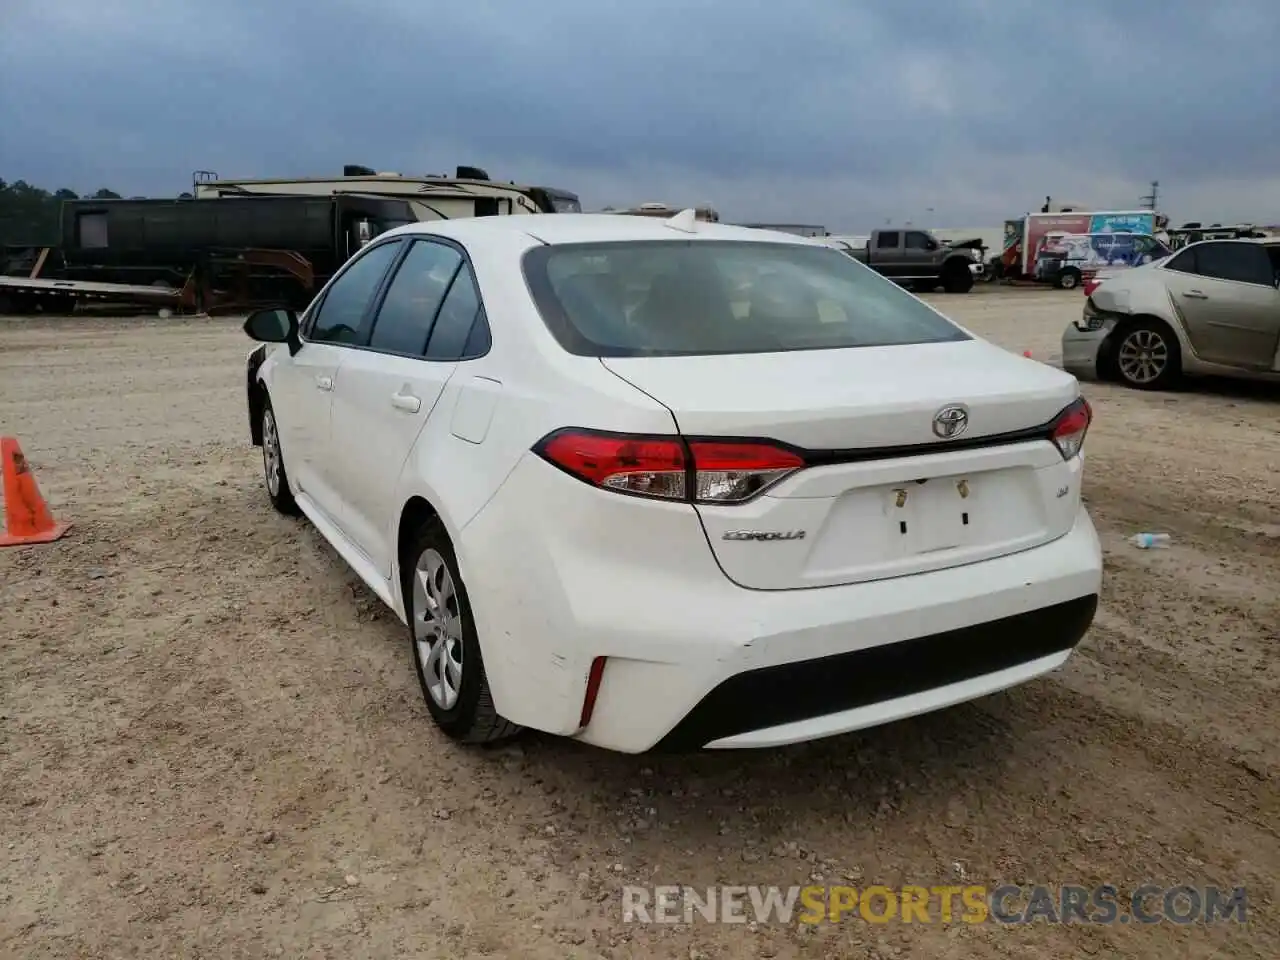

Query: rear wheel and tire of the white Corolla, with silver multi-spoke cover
[401,517,521,744]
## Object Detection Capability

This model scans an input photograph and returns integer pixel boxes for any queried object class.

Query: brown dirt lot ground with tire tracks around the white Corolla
[0,292,1280,960]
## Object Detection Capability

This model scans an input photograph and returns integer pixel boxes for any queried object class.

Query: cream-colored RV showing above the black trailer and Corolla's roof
[192,165,582,220]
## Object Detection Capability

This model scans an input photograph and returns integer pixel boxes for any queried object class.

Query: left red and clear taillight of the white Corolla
[534,430,805,503]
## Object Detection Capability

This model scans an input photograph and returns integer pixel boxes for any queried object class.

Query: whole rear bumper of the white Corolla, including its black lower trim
[460,463,1102,753]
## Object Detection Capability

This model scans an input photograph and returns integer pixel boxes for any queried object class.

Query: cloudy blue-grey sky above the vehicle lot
[0,0,1280,229]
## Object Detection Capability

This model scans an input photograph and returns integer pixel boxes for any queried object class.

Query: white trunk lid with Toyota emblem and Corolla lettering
[600,339,1080,590]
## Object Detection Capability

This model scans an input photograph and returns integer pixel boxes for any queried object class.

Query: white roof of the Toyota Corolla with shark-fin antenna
[383,214,814,246]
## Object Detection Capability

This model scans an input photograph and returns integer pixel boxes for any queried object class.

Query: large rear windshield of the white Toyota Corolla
[524,239,969,357]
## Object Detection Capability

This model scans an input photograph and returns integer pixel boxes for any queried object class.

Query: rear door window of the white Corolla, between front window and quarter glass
[369,241,462,357]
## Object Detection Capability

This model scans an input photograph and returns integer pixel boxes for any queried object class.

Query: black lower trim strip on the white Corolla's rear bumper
[653,594,1098,753]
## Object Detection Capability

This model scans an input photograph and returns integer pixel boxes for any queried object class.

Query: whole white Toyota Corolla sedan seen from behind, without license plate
[244,211,1102,753]
